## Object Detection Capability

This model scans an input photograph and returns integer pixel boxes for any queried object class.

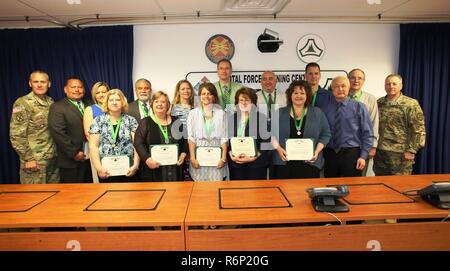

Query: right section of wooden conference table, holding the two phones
[185,174,450,250]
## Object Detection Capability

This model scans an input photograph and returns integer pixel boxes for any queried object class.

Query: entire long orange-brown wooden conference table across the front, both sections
[0,174,450,251]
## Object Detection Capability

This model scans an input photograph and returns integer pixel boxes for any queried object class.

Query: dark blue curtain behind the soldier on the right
[399,23,450,174]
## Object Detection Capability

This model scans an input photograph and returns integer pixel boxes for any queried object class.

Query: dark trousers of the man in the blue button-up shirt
[323,147,362,178]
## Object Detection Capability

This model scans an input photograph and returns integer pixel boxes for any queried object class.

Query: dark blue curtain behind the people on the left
[0,26,133,183]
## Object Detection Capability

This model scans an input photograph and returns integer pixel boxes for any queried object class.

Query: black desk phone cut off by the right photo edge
[417,182,450,209]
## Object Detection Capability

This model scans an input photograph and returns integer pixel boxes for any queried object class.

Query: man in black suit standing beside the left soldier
[48,77,92,183]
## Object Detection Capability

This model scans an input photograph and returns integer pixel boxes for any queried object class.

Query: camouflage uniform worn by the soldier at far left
[9,92,59,184]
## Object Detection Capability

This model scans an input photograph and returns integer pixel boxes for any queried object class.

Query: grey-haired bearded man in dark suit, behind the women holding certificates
[128,78,152,122]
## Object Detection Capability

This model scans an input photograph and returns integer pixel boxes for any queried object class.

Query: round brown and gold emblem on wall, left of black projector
[205,34,234,64]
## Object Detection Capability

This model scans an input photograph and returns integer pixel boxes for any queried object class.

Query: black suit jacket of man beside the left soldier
[48,98,92,168]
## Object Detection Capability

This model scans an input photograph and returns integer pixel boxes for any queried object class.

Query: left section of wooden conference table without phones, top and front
[0,182,193,250]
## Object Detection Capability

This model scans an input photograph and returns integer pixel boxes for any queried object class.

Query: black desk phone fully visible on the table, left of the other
[306,185,349,212]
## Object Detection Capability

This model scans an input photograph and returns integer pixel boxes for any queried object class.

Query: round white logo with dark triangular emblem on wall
[297,34,325,63]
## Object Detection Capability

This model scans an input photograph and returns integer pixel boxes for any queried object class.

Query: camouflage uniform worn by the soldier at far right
[374,94,425,176]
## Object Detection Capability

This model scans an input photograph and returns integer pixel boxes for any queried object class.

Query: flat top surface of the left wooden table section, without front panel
[0,182,193,228]
